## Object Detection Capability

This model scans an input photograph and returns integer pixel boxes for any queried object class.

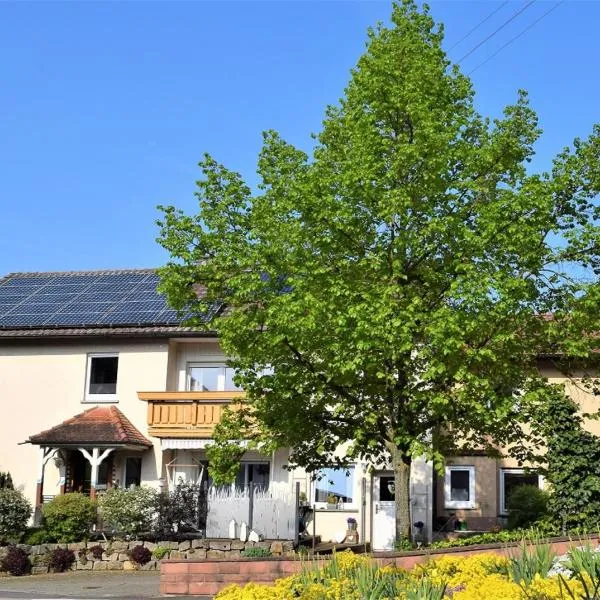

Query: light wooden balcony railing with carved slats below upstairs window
[138,392,245,439]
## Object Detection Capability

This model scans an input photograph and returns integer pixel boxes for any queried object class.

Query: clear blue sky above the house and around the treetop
[0,0,600,274]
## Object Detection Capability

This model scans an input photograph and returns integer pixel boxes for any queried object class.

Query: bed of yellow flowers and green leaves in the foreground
[216,545,600,600]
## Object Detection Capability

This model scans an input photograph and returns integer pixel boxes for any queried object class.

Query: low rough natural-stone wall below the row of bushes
[0,539,294,575]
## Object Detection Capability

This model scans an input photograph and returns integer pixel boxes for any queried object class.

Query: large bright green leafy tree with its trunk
[159,1,600,538]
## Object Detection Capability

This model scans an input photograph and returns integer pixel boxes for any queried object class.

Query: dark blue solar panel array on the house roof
[0,270,186,329]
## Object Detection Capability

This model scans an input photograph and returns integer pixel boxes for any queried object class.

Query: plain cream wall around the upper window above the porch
[0,340,168,502]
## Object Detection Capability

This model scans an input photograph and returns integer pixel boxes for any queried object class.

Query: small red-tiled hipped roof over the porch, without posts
[27,406,152,448]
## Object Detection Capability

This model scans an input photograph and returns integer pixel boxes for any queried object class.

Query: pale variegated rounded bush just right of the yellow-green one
[98,486,157,536]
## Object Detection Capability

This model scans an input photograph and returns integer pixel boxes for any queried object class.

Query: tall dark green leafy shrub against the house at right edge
[533,389,600,530]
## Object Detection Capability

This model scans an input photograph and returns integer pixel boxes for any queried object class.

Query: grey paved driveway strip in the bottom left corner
[0,571,207,600]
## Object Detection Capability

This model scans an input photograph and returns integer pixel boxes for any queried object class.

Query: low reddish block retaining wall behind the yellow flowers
[160,536,595,596]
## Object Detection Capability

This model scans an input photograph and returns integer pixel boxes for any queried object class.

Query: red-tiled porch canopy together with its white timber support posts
[25,406,152,505]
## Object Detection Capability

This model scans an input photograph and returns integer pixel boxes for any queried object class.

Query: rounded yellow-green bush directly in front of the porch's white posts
[43,493,96,543]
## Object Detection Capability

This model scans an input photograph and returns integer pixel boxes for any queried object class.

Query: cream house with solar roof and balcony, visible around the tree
[0,269,594,549]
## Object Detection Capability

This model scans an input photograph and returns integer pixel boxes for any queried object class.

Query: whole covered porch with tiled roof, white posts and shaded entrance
[24,406,152,514]
